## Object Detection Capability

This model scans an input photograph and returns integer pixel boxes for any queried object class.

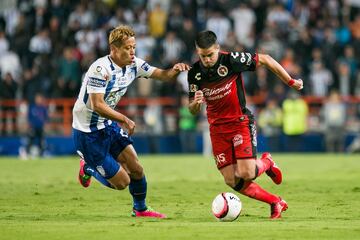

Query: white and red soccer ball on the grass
[212,192,242,222]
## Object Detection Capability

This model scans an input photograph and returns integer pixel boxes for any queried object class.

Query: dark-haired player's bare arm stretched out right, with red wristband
[258,54,303,90]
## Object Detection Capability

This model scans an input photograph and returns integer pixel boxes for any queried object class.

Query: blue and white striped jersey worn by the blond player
[72,56,155,132]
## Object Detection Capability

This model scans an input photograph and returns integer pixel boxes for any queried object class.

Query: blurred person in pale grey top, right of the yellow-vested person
[322,91,346,152]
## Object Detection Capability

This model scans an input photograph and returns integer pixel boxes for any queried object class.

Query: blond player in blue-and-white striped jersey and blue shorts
[72,26,189,218]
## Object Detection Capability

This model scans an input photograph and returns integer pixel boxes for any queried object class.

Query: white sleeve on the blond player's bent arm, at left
[86,63,110,93]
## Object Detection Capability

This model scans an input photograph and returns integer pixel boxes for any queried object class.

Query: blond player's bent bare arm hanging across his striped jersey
[89,93,136,135]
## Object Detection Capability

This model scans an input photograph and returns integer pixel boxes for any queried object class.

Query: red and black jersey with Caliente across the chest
[188,52,258,124]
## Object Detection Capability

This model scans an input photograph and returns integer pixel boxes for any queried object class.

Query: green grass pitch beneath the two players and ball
[0,154,360,240]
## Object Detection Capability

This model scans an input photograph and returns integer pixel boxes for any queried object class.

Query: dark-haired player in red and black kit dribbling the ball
[188,31,303,219]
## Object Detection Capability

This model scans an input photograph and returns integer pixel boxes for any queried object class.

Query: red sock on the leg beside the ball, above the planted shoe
[239,181,279,204]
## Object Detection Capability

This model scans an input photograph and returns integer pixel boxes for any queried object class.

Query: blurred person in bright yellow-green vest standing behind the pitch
[282,91,309,152]
